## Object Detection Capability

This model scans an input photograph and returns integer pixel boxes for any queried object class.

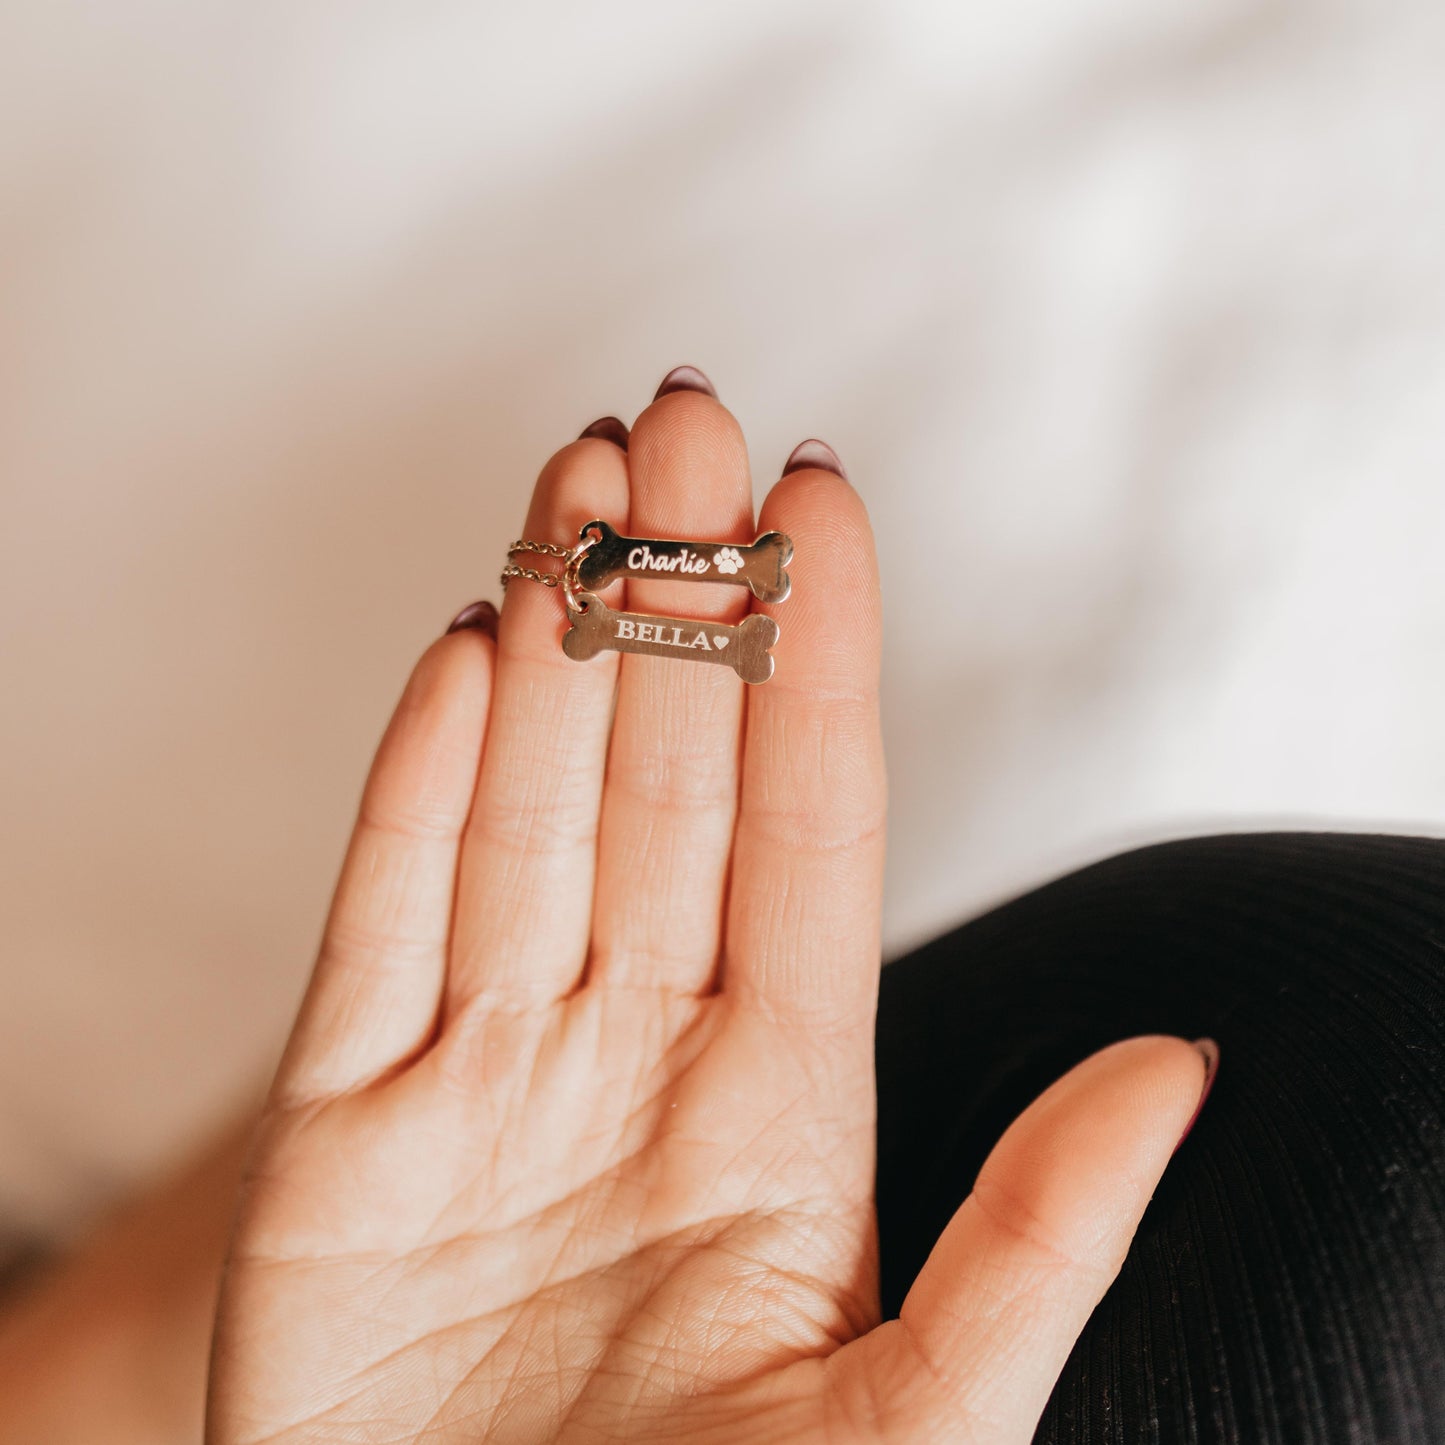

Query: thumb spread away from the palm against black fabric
[843,1035,1218,1441]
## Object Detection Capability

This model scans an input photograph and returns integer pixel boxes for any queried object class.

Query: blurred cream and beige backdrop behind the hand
[0,0,1445,1265]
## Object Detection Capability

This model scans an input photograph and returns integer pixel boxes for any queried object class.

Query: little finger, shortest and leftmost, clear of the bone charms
[276,621,494,1104]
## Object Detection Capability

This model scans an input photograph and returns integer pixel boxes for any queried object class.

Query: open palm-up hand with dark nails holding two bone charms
[208,392,1202,1445]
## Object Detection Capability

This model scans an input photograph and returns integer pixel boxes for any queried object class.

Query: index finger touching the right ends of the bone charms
[723,467,886,1023]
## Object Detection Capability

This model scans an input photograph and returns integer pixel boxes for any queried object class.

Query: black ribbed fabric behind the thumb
[879,834,1445,1445]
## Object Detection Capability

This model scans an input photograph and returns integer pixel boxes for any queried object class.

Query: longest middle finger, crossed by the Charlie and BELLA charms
[591,373,753,993]
